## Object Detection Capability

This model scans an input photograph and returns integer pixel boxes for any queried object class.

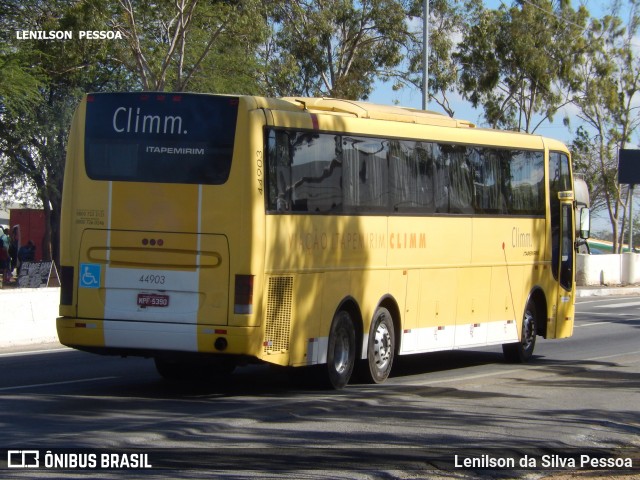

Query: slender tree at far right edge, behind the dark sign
[570,0,640,252]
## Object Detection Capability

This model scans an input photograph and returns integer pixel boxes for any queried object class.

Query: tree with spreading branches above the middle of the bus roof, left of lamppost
[264,0,415,99]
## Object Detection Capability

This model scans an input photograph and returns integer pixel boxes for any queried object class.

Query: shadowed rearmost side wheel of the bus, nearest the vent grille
[327,310,356,390]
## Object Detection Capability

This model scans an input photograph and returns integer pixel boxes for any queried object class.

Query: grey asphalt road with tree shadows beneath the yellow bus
[0,297,640,478]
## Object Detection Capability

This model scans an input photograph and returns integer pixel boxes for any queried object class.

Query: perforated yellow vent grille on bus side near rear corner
[264,277,293,353]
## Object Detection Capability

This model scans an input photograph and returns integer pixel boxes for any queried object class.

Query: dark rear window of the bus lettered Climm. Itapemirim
[85,93,238,185]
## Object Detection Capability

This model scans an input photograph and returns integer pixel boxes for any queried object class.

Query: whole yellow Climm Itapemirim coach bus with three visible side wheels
[57,92,576,388]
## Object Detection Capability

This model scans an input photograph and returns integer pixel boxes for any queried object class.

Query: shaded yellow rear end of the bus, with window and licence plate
[58,93,264,364]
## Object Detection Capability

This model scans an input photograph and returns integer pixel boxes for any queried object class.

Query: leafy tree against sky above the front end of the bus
[455,0,587,133]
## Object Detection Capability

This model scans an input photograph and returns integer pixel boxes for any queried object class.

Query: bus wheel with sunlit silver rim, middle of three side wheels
[361,307,396,383]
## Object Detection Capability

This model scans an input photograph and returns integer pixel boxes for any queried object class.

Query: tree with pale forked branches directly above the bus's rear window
[109,0,266,93]
